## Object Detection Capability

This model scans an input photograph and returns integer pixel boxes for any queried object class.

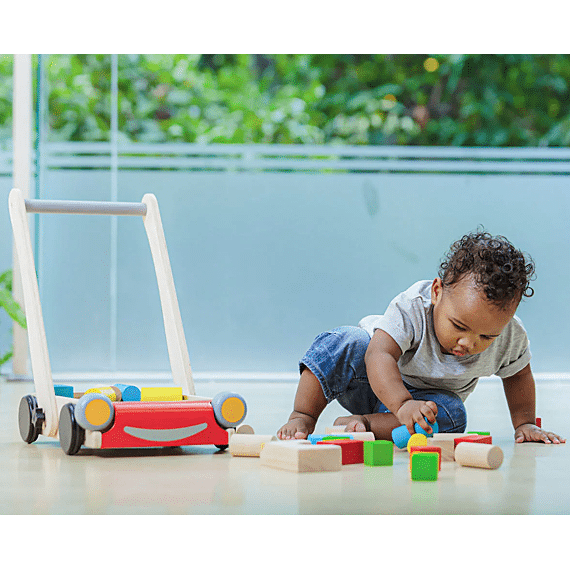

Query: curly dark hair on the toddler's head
[438,230,535,308]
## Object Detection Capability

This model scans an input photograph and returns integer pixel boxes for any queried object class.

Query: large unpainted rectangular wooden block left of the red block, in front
[259,440,342,473]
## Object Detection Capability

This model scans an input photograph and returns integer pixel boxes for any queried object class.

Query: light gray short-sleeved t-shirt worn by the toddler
[358,281,531,401]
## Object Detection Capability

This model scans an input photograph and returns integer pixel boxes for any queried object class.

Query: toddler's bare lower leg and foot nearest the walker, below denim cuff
[277,368,327,439]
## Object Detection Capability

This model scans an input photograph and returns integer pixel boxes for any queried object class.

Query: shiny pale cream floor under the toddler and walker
[0,374,570,514]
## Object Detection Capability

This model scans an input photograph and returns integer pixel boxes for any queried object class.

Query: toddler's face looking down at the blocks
[431,276,518,357]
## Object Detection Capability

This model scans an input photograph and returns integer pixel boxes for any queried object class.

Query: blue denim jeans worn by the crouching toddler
[299,326,467,433]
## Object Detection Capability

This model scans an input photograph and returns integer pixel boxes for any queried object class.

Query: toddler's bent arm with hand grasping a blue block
[365,329,437,434]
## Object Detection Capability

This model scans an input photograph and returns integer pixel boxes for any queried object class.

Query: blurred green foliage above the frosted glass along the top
[0,54,570,147]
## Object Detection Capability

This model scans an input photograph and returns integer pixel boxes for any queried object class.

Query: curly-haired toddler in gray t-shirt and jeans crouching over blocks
[277,231,566,443]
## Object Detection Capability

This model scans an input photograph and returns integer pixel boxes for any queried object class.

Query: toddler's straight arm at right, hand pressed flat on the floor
[503,364,566,443]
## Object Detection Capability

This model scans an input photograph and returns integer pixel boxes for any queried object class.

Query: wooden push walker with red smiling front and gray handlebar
[9,188,247,455]
